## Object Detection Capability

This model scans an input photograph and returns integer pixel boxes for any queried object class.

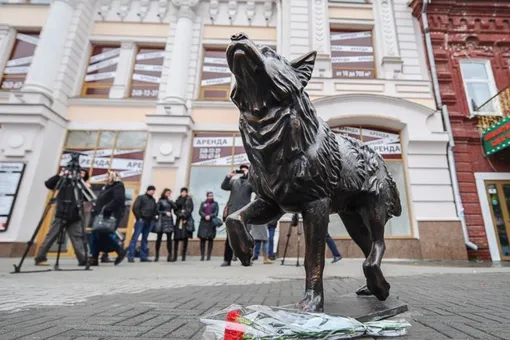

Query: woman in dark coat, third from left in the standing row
[174,188,195,261]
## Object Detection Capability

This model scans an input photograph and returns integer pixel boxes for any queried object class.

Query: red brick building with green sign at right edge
[411,0,510,261]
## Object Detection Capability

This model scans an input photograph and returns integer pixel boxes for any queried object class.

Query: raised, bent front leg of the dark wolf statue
[225,198,283,266]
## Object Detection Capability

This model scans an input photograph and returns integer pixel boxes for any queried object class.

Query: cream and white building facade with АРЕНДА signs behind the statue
[0,0,467,259]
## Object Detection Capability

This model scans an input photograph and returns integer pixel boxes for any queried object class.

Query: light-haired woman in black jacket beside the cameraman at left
[90,171,127,266]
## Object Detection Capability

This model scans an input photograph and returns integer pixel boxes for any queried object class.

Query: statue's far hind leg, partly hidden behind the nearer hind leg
[339,212,372,295]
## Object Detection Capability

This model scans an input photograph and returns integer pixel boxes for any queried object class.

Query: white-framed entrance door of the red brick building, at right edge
[485,181,510,261]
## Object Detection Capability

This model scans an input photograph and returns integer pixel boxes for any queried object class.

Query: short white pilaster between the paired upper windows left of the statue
[110,42,136,99]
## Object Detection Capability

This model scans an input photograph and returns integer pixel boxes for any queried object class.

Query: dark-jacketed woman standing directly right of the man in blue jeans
[153,189,177,262]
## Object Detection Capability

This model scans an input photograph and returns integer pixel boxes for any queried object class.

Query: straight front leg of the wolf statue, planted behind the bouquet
[297,198,330,312]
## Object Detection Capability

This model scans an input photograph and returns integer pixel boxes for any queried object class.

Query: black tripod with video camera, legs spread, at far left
[11,156,96,274]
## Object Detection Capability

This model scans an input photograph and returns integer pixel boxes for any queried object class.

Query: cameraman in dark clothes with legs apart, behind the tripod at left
[35,169,89,266]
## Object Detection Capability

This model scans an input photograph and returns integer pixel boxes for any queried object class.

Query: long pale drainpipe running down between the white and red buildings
[421,0,478,250]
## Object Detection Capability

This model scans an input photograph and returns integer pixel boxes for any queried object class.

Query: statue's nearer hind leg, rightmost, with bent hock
[361,203,390,301]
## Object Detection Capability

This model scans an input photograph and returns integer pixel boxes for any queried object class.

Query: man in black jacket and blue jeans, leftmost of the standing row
[128,185,157,263]
